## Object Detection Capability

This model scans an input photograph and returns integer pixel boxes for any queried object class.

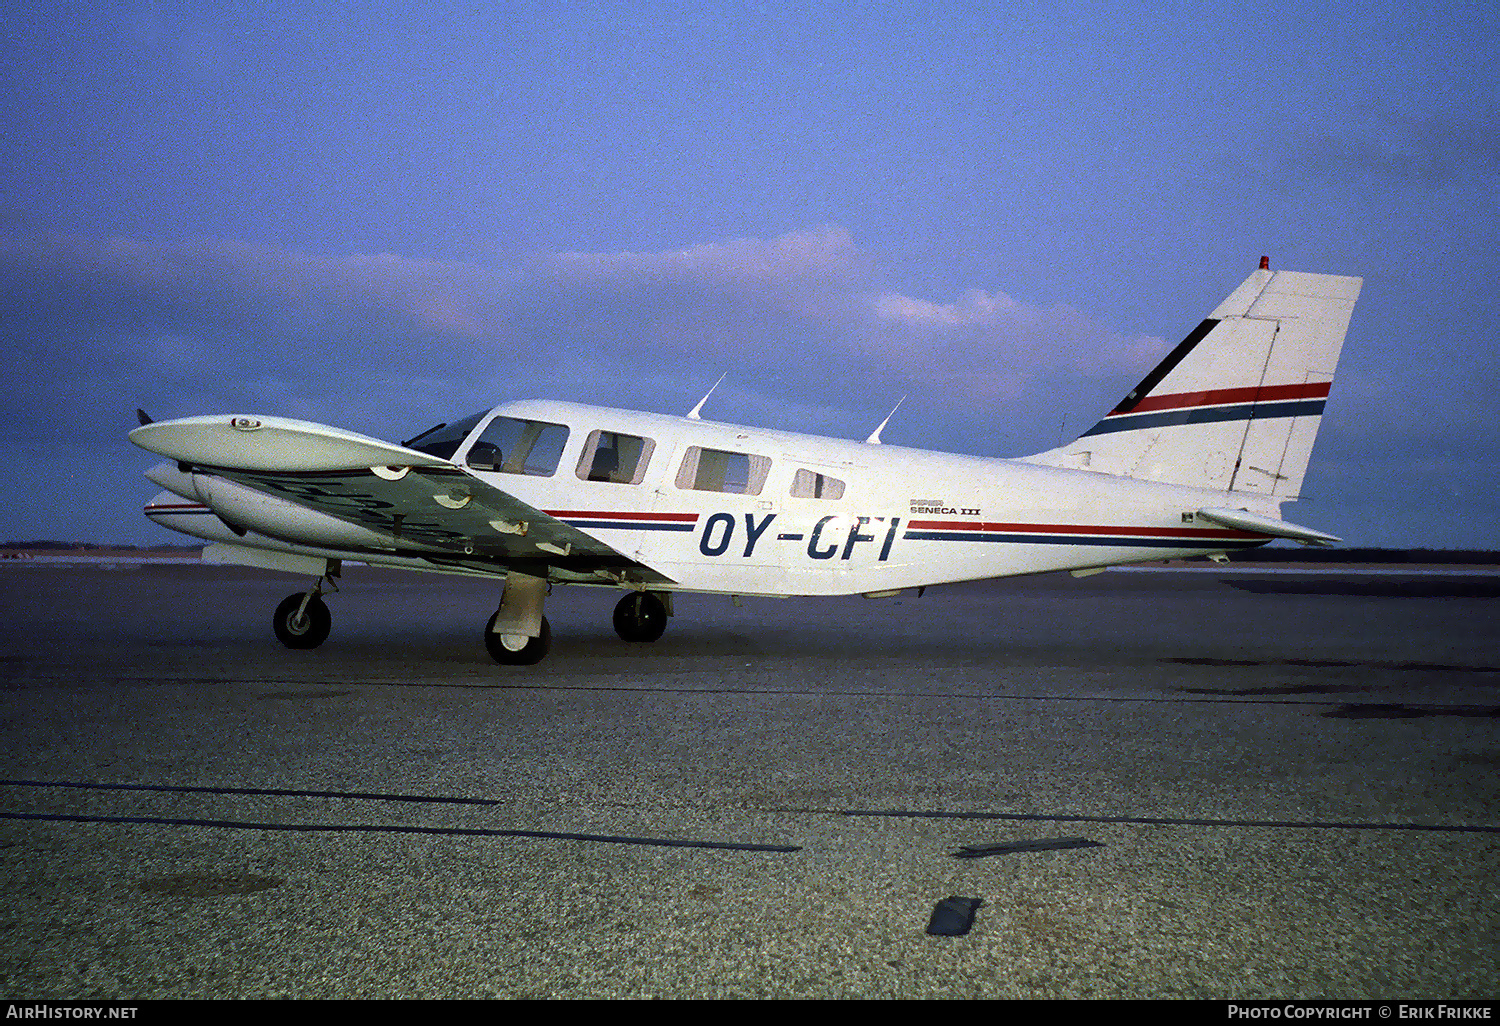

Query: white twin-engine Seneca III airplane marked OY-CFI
[131,260,1362,665]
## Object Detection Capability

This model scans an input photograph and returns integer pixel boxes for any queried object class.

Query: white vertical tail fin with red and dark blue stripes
[1025,260,1364,501]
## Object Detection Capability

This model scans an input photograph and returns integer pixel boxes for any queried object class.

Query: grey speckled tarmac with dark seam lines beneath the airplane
[0,564,1500,999]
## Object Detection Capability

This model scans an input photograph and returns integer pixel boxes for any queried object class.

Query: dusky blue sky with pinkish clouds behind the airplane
[0,2,1500,548]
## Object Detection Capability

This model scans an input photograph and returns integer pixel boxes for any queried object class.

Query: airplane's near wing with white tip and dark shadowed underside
[131,417,671,584]
